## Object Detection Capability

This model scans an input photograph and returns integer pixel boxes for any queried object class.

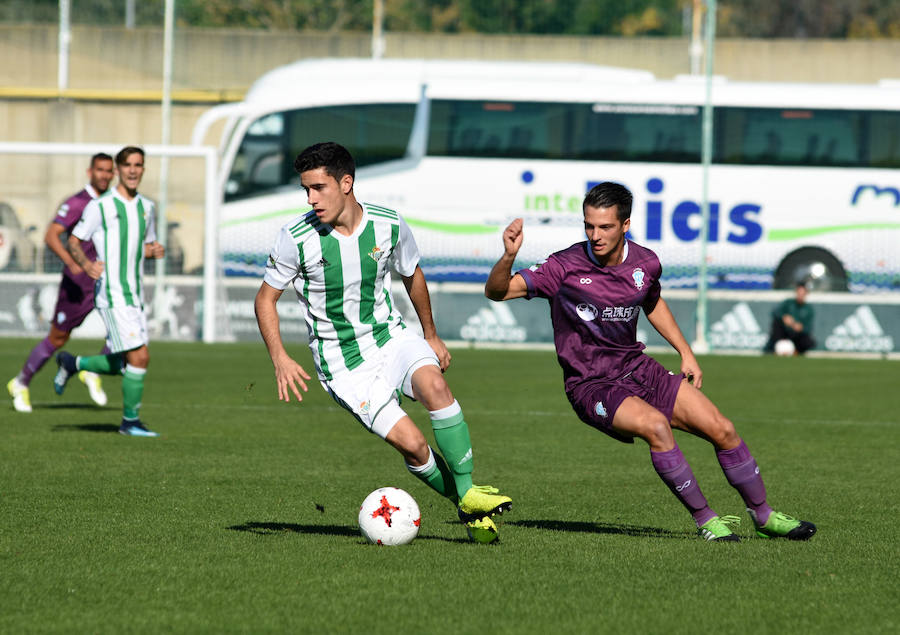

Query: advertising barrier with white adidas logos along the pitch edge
[0,274,900,356]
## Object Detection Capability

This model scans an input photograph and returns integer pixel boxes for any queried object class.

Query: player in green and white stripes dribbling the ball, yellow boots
[256,142,512,542]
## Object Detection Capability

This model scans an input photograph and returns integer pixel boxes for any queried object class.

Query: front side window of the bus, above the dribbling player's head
[225,104,416,201]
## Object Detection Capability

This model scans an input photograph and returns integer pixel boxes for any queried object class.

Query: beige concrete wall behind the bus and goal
[0,25,900,269]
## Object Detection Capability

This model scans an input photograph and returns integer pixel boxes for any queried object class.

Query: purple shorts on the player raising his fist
[567,355,684,443]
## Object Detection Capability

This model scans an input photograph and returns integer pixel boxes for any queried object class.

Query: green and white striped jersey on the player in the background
[72,187,156,309]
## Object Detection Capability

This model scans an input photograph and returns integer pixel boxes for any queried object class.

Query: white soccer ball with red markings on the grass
[359,487,422,545]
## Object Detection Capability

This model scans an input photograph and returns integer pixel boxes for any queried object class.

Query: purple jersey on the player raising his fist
[518,241,662,393]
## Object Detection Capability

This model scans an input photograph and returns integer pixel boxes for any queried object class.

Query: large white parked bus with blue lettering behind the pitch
[194,59,900,292]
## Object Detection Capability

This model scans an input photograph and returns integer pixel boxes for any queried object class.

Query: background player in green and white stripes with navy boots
[53,146,165,437]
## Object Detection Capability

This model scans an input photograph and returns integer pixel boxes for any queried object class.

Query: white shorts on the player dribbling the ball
[322,333,440,439]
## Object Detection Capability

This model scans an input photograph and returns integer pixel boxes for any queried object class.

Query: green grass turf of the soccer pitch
[0,340,900,635]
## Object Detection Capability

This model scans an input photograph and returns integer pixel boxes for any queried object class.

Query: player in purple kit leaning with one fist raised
[485,182,816,541]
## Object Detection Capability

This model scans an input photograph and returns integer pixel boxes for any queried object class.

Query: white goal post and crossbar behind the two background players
[0,142,227,343]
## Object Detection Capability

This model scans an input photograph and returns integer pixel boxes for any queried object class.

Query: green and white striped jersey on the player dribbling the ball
[264,203,419,381]
